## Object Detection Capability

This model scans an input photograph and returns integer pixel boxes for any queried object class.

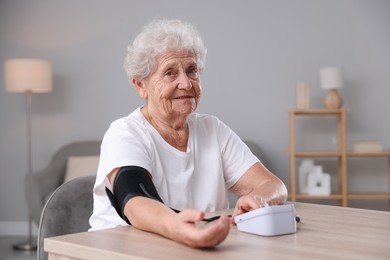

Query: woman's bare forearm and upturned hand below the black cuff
[125,197,230,248]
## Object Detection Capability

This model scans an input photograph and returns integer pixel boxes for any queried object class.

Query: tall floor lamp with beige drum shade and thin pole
[4,59,52,251]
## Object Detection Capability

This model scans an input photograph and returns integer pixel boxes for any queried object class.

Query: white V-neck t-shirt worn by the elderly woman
[90,108,259,230]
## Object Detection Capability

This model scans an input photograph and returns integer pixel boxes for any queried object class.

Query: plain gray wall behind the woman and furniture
[0,0,390,235]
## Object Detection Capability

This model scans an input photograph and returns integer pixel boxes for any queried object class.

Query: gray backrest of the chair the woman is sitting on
[37,176,95,260]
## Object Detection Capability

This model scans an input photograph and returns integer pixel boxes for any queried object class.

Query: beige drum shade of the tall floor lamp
[4,59,52,93]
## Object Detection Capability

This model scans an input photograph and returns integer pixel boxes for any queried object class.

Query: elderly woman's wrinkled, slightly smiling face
[144,51,202,119]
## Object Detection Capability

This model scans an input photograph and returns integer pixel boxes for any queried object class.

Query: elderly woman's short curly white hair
[124,19,207,80]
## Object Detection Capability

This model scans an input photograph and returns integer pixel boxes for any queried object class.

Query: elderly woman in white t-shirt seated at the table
[90,20,287,247]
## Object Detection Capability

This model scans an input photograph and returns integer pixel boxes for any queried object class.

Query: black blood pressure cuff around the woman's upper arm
[106,166,163,224]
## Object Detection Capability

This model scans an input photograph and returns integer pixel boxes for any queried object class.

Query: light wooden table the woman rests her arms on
[44,202,390,260]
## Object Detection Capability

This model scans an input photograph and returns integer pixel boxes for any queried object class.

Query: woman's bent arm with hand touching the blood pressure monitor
[230,163,287,221]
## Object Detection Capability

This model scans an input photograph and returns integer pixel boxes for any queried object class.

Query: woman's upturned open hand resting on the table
[170,209,230,248]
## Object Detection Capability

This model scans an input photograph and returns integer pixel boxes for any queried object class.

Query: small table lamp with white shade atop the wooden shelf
[320,67,344,109]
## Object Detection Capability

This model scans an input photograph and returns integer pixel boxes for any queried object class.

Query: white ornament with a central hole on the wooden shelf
[307,166,330,196]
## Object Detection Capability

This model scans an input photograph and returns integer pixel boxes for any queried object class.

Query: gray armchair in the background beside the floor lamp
[25,141,101,225]
